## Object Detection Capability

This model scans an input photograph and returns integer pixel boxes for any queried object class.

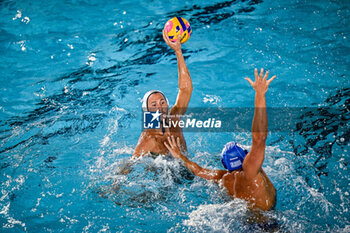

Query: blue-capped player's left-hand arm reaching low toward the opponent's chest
[164,136,227,182]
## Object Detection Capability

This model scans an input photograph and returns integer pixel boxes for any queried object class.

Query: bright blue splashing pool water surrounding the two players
[0,0,350,232]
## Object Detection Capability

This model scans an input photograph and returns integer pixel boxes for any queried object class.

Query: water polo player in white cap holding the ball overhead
[133,30,193,157]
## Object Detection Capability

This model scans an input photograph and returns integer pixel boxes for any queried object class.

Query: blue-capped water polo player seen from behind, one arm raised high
[164,69,276,210]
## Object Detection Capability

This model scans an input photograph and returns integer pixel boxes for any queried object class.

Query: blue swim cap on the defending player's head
[221,142,248,172]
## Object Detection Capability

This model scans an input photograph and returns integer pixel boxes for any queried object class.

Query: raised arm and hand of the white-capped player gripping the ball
[163,30,193,115]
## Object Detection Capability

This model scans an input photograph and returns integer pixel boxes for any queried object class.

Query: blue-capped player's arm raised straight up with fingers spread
[243,69,276,179]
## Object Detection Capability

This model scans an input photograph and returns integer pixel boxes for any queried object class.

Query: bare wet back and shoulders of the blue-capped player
[222,169,276,210]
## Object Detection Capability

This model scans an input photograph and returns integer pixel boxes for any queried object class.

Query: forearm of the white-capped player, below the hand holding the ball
[175,50,193,92]
